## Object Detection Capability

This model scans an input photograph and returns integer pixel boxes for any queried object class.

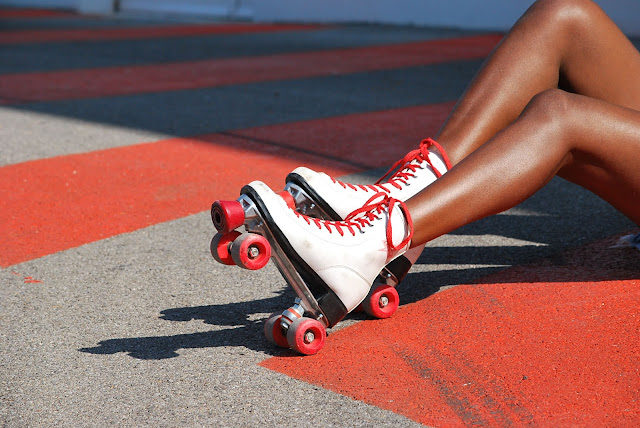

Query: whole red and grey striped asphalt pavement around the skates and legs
[0,9,640,427]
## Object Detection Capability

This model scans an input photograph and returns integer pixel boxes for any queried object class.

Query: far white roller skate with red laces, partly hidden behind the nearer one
[285,138,451,287]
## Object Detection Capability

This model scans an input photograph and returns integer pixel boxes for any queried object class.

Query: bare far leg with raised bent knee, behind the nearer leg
[436,0,640,164]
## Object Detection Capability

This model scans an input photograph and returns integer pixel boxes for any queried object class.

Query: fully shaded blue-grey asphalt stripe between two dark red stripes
[0,24,477,74]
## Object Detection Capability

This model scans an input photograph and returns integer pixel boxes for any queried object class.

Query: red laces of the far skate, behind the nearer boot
[333,138,451,193]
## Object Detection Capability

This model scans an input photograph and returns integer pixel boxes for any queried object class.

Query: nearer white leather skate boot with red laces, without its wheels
[241,181,413,325]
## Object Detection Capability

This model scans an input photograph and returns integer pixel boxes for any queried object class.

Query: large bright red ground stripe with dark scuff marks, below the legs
[262,236,640,427]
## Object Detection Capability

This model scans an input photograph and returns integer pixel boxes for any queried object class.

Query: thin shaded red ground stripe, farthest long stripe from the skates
[0,23,325,44]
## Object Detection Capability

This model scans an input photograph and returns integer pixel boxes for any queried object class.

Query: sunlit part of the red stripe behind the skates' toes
[0,135,353,266]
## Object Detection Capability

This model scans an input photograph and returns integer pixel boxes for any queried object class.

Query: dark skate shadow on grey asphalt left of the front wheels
[79,289,294,360]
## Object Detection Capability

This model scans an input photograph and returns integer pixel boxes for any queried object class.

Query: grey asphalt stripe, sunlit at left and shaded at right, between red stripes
[0,61,481,165]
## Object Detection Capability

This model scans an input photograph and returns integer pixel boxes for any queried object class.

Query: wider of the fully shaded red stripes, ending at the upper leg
[0,35,500,104]
